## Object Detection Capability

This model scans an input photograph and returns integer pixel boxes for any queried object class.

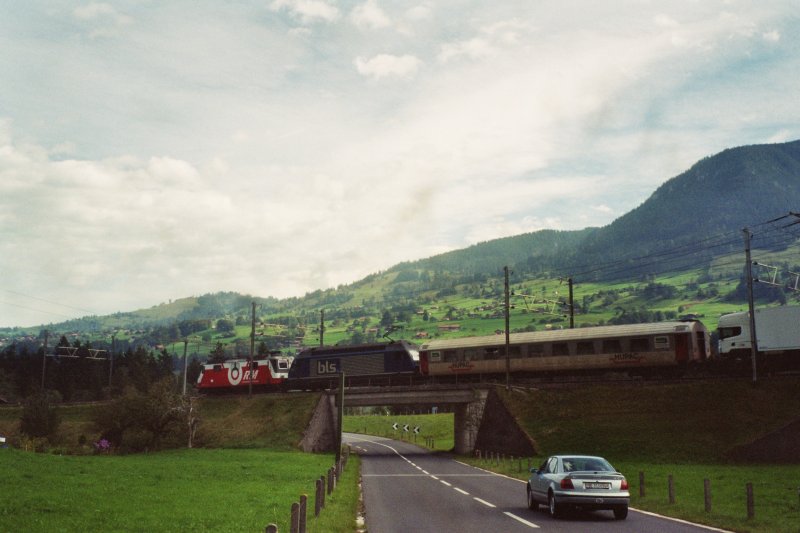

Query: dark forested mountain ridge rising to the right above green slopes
[400,141,800,279]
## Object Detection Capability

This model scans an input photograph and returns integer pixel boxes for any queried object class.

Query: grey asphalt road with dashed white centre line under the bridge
[343,433,732,533]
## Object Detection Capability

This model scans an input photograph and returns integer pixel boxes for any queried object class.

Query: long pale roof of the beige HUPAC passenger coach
[420,320,705,350]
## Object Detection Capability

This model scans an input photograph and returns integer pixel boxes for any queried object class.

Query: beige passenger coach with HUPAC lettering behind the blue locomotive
[420,321,710,376]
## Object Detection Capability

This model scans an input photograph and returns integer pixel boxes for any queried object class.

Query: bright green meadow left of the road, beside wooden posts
[0,449,350,532]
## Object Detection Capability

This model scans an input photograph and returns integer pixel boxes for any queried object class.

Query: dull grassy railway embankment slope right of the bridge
[498,377,800,464]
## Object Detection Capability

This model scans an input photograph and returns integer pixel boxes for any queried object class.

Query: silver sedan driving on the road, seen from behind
[527,455,630,520]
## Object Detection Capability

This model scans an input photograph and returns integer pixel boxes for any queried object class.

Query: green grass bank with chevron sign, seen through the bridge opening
[342,413,454,451]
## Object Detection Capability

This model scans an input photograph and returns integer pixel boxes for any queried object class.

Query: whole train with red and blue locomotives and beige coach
[198,314,800,390]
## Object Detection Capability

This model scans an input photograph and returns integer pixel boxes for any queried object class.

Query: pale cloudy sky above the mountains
[0,0,800,327]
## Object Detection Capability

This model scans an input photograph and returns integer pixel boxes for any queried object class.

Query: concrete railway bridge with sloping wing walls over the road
[301,384,535,455]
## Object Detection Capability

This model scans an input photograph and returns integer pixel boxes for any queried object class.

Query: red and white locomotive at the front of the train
[195,353,293,392]
